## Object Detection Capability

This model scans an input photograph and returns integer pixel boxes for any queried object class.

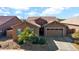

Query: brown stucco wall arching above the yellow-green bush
[12,22,39,40]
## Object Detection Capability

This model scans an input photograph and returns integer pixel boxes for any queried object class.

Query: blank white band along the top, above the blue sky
[0,0,79,9]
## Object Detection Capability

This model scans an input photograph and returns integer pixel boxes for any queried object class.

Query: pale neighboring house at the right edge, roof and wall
[61,16,79,32]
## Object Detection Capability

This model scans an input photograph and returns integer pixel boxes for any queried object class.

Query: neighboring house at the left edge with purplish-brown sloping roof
[0,16,21,36]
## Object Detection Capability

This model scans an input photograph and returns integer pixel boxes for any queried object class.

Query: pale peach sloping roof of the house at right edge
[61,16,79,25]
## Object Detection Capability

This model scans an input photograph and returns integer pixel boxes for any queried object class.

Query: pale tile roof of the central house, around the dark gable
[26,16,58,27]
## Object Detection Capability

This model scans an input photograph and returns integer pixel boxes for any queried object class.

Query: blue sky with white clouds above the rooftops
[0,7,79,19]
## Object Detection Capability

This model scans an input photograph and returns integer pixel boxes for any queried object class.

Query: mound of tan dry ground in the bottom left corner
[0,40,20,49]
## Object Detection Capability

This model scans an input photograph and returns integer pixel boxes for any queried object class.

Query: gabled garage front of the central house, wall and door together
[45,21,67,36]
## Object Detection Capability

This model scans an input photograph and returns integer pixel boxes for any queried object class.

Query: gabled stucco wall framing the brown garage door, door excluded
[45,22,67,36]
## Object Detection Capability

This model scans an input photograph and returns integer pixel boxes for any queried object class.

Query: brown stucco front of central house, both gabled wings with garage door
[9,16,68,40]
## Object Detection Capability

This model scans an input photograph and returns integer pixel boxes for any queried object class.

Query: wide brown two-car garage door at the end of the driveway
[45,28,64,37]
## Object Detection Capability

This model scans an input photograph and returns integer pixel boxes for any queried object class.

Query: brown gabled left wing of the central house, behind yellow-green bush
[11,20,39,40]
